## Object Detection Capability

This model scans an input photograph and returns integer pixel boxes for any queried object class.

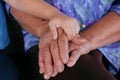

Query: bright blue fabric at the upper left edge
[0,0,9,50]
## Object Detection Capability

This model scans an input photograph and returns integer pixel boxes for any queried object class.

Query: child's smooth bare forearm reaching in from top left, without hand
[4,0,61,19]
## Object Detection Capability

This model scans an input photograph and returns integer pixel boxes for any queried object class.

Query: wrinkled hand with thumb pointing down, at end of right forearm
[67,32,91,67]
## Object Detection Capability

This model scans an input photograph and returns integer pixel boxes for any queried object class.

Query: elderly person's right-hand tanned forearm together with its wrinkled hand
[67,12,120,67]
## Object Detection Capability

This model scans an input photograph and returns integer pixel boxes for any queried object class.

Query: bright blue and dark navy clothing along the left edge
[0,0,18,80]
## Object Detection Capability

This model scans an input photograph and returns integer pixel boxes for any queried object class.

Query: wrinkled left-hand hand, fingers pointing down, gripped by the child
[39,30,69,79]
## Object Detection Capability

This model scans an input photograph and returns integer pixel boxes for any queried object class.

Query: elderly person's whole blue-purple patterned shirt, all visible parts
[6,0,120,74]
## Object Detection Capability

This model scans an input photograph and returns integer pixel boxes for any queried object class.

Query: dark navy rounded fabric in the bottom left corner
[0,53,19,80]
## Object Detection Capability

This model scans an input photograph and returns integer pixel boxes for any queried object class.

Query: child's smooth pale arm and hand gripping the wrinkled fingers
[4,0,80,40]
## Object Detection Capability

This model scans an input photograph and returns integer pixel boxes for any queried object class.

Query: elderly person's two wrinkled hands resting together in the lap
[38,28,91,79]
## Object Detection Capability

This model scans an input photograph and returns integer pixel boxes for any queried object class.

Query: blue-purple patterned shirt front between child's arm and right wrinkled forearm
[49,0,113,28]
